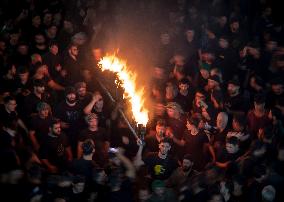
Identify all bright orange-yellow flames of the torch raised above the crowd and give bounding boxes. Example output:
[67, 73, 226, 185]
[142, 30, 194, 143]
[99, 55, 149, 126]
